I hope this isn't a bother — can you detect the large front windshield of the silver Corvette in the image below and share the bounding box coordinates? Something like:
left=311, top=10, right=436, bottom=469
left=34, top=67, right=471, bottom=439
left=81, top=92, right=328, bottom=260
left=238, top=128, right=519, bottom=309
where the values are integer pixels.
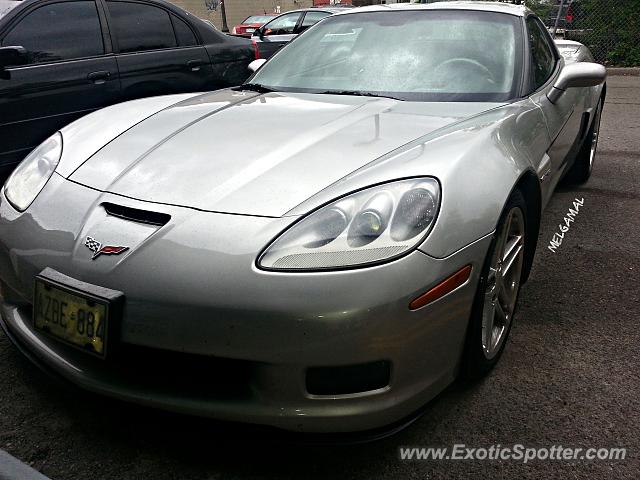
left=250, top=10, right=522, bottom=102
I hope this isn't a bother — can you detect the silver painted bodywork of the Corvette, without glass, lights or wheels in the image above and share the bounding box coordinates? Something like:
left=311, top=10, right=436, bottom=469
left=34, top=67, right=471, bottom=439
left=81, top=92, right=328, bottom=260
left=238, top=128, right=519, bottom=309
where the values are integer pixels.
left=0, top=2, right=602, bottom=431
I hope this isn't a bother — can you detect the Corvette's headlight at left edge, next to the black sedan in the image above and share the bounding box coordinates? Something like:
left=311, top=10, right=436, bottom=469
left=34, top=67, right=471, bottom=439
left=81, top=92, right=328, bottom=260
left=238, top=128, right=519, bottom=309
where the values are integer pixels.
left=4, top=132, right=62, bottom=212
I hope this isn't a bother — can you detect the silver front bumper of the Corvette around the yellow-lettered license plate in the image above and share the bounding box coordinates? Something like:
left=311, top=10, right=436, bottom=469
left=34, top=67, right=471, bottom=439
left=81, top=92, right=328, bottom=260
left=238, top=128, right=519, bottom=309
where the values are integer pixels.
left=0, top=176, right=491, bottom=432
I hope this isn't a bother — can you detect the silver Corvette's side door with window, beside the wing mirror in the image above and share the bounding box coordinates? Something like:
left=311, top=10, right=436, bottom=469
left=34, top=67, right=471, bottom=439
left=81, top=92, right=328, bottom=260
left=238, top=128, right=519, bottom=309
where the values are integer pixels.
left=526, top=16, right=584, bottom=203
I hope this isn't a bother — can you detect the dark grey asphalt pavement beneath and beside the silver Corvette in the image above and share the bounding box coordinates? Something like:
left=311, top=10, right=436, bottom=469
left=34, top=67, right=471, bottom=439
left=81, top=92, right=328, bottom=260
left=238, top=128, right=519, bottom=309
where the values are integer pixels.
left=0, top=76, right=640, bottom=480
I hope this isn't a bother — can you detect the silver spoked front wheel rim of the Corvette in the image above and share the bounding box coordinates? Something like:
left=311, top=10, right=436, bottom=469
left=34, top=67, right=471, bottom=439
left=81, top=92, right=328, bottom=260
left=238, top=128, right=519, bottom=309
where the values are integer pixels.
left=482, top=207, right=525, bottom=360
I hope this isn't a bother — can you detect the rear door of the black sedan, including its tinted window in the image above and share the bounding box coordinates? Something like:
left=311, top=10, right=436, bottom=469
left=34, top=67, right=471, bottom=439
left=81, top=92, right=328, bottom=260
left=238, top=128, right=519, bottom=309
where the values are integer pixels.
left=106, top=0, right=213, bottom=99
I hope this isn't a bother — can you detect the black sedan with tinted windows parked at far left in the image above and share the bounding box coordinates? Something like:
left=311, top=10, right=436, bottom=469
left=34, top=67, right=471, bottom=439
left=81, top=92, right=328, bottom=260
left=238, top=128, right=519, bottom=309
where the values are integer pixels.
left=0, top=0, right=255, bottom=181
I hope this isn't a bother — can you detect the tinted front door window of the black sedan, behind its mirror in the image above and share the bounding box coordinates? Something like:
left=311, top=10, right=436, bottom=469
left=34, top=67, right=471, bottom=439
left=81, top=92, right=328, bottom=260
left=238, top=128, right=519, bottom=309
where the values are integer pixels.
left=2, top=1, right=104, bottom=64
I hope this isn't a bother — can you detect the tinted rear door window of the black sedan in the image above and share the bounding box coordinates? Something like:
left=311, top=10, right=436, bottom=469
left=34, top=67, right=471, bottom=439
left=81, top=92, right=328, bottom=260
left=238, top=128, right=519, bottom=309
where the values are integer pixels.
left=107, top=2, right=177, bottom=53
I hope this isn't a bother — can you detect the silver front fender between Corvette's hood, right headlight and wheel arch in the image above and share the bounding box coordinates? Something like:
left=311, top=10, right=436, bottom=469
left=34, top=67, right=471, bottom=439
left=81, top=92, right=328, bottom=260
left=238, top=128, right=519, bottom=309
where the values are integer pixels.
left=290, top=100, right=549, bottom=258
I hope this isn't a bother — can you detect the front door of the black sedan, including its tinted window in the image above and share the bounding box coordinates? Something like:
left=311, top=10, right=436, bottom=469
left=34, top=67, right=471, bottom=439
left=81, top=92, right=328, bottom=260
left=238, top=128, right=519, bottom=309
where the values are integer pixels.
left=0, top=0, right=120, bottom=178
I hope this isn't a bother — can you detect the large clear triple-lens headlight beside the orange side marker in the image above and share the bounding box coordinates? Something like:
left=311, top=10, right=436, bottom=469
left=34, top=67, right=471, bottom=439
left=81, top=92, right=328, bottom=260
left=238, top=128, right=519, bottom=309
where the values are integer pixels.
left=258, top=178, right=440, bottom=270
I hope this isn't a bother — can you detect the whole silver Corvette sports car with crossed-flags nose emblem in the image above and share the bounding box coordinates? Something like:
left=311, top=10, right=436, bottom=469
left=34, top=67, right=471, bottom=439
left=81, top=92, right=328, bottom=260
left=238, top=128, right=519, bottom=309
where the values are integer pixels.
left=0, top=2, right=606, bottom=432
